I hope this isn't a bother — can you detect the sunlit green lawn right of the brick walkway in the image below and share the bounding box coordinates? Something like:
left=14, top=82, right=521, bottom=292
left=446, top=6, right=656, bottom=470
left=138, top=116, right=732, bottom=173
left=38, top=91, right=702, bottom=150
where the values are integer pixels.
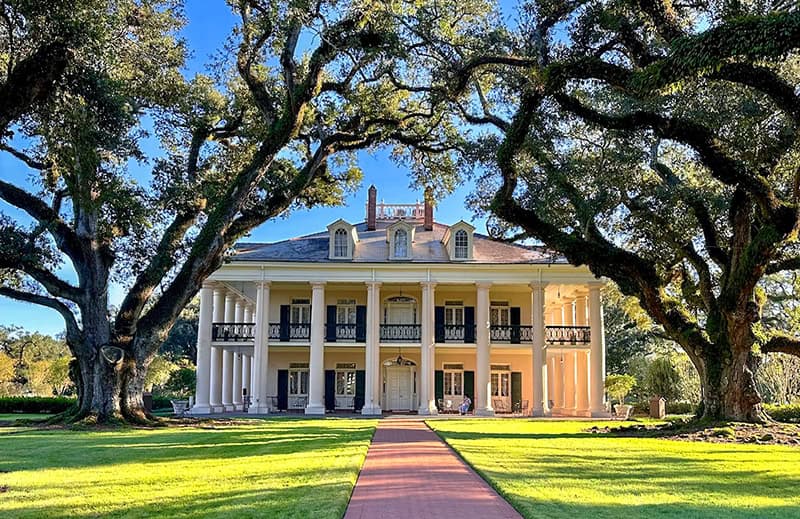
left=428, top=420, right=800, bottom=519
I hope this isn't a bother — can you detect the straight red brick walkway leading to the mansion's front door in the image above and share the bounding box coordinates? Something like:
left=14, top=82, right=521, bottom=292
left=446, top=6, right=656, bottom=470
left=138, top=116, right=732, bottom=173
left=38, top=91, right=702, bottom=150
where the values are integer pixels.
left=345, top=418, right=520, bottom=519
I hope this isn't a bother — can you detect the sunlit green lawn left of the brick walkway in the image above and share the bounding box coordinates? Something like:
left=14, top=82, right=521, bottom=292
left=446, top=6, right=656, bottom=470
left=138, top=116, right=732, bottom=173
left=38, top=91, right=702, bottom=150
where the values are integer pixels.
left=0, top=418, right=375, bottom=518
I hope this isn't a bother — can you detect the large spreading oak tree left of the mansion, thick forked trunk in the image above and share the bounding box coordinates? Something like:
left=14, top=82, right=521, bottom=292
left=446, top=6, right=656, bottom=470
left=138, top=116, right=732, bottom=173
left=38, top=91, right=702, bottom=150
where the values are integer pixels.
left=0, top=0, right=466, bottom=421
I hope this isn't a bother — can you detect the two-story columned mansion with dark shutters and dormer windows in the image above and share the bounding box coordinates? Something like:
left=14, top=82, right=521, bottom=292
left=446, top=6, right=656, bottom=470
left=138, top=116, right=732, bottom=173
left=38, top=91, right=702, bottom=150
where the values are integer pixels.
left=191, top=186, right=605, bottom=416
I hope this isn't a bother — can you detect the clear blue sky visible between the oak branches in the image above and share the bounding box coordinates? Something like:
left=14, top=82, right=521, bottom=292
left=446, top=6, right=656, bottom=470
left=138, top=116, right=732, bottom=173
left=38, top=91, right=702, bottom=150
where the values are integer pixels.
left=0, top=0, right=514, bottom=335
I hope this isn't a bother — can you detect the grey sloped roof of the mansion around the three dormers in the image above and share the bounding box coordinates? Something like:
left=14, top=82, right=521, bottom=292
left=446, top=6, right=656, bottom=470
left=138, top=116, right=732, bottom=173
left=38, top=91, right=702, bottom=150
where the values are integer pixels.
left=231, top=221, right=567, bottom=264
